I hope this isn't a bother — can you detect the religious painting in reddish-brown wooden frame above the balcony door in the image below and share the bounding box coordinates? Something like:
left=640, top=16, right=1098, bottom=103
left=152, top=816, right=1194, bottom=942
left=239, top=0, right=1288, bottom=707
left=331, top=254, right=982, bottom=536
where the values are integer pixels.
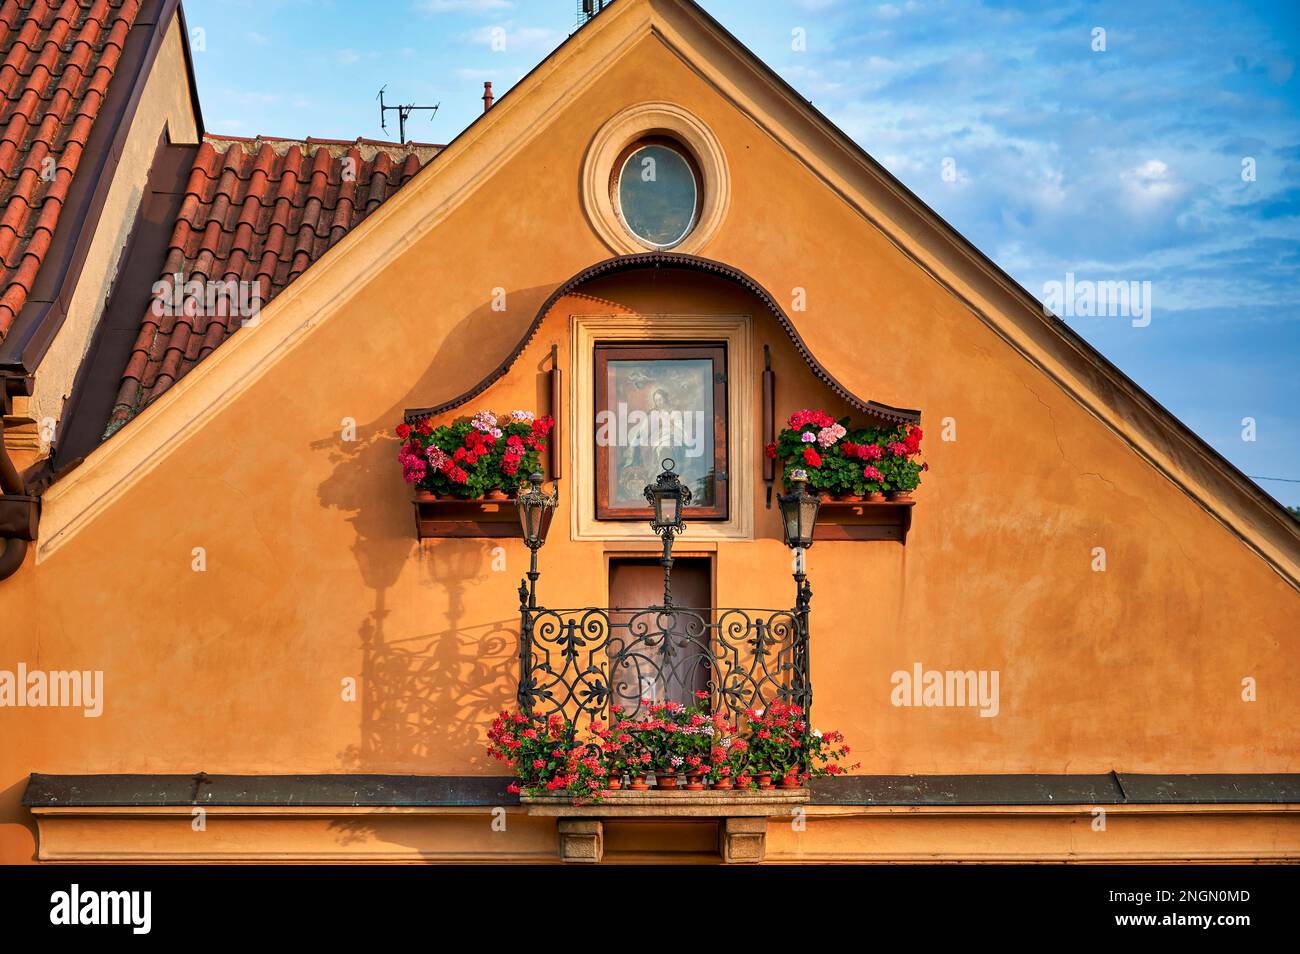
left=594, top=343, right=727, bottom=520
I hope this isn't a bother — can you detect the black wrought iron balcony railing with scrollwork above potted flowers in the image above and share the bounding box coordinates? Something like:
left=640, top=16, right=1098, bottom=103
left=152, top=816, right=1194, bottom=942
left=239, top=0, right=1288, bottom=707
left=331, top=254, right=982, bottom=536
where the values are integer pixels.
left=519, top=573, right=813, bottom=719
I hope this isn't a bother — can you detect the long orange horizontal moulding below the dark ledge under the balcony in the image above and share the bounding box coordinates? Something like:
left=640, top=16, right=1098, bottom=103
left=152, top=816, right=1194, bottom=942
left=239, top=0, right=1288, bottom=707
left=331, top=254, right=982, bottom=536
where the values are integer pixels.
left=31, top=803, right=1300, bottom=863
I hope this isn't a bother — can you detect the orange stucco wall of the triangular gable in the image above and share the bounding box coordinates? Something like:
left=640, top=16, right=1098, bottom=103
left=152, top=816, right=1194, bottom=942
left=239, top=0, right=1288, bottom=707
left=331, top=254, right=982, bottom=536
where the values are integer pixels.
left=0, top=20, right=1300, bottom=862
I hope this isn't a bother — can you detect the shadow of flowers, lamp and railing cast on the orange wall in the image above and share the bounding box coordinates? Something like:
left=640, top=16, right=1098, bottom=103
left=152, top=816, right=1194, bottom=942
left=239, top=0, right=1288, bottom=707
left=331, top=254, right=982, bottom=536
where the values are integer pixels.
left=312, top=295, right=559, bottom=775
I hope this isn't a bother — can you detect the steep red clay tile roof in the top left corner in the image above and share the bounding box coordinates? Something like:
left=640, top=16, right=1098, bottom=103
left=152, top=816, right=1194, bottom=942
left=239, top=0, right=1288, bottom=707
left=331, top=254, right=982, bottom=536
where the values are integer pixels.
left=0, top=0, right=139, bottom=341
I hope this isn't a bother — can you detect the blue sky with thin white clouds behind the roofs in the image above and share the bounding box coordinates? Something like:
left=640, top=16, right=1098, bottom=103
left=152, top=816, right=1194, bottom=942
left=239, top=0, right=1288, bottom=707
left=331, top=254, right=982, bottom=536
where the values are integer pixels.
left=185, top=0, right=1300, bottom=506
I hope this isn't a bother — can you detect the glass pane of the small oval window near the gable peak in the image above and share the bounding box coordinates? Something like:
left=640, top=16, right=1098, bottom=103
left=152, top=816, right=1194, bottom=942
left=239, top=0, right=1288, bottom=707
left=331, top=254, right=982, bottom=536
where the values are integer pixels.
left=619, top=146, right=696, bottom=248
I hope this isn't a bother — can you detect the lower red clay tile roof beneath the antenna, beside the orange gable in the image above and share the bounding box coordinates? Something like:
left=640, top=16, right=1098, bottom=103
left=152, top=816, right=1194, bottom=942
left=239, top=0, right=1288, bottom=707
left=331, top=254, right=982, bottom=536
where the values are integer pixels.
left=105, top=136, right=441, bottom=435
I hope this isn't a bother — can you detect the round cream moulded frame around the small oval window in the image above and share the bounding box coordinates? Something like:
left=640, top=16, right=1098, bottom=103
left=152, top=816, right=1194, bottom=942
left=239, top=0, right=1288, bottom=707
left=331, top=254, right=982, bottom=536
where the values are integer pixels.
left=581, top=103, right=731, bottom=255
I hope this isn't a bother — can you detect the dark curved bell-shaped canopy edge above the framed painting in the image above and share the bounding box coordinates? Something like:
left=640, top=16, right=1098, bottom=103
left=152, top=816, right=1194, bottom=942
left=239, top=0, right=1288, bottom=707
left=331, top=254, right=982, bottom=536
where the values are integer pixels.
left=406, top=252, right=920, bottom=424
